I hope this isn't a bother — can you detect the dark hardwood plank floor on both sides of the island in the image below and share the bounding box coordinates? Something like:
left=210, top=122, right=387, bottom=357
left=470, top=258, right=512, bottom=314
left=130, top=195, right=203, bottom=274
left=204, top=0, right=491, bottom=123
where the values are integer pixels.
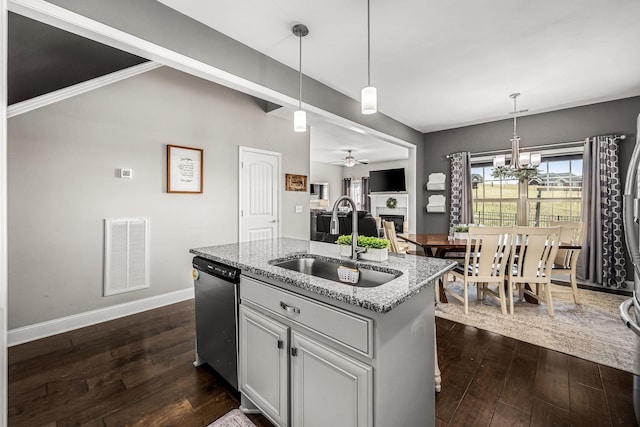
left=9, top=301, right=635, bottom=427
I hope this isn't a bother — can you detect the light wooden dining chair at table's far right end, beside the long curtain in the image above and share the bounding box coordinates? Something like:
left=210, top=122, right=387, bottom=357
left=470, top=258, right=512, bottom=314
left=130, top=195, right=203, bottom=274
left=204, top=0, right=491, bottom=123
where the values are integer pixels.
left=550, top=222, right=583, bottom=304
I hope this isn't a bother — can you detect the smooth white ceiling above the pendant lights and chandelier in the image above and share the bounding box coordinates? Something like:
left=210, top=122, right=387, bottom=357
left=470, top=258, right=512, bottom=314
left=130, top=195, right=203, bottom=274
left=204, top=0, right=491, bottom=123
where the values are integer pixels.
left=160, top=0, right=640, bottom=159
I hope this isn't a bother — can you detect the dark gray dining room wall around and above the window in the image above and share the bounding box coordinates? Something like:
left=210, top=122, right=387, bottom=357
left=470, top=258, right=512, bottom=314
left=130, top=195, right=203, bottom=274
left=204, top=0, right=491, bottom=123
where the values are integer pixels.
left=417, top=97, right=640, bottom=233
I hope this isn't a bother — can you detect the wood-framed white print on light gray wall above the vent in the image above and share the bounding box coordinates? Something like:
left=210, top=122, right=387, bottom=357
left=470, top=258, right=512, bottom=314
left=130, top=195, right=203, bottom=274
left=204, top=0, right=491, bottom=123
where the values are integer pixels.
left=167, top=145, right=204, bottom=193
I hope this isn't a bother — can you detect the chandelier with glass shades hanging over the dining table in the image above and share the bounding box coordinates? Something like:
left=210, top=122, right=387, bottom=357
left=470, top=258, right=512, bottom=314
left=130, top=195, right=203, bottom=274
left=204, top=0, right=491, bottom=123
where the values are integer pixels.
left=492, top=93, right=542, bottom=181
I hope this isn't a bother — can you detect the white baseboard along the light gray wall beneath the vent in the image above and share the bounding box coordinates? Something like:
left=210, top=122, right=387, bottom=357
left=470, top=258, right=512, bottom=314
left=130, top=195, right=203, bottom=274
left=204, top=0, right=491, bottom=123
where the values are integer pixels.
left=7, top=288, right=193, bottom=347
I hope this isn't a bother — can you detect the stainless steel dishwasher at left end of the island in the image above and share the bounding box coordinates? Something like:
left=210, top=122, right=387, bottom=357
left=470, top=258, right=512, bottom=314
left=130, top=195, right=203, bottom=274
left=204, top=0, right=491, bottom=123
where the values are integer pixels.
left=193, top=257, right=240, bottom=390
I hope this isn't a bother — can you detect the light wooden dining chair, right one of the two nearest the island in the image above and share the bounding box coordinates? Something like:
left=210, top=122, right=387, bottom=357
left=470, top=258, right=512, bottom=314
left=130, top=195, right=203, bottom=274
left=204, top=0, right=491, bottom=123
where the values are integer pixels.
left=507, top=227, right=560, bottom=317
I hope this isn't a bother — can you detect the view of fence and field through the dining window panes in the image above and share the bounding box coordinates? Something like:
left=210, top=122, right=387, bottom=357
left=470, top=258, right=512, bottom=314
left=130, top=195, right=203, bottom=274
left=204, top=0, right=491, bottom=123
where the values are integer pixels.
left=471, top=157, right=582, bottom=227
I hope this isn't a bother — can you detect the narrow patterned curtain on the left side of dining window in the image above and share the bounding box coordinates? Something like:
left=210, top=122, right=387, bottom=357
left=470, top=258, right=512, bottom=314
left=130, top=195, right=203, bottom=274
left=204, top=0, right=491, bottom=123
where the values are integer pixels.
left=449, top=151, right=473, bottom=227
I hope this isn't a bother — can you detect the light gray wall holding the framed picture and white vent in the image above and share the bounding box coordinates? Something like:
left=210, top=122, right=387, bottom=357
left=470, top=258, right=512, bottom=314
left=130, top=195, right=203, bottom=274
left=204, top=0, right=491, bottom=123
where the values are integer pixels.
left=8, top=68, right=310, bottom=328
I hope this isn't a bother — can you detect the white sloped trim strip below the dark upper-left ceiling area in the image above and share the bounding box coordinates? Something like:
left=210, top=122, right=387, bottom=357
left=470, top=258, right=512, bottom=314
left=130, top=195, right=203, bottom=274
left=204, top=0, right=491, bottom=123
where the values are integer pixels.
left=7, top=61, right=162, bottom=118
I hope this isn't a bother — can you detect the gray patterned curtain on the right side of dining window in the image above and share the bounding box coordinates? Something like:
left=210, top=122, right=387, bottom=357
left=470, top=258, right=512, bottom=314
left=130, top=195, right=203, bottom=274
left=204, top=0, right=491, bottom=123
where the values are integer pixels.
left=577, top=136, right=626, bottom=288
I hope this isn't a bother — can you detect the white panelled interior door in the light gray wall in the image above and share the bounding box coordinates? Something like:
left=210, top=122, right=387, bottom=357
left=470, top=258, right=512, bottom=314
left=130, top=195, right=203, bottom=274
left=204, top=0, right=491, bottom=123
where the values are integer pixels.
left=238, top=147, right=281, bottom=242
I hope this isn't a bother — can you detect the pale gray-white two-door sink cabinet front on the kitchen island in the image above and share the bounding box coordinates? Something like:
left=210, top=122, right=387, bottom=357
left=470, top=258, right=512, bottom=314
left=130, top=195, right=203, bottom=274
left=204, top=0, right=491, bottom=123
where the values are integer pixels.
left=239, top=280, right=373, bottom=427
